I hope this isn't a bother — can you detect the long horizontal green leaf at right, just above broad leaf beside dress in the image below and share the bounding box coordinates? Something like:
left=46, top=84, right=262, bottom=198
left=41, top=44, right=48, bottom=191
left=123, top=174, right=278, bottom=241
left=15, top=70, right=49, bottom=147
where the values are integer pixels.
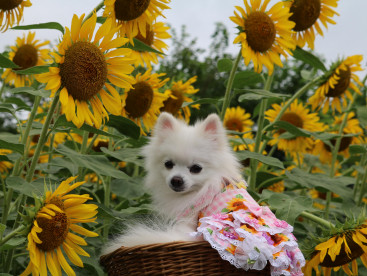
left=285, top=168, right=355, bottom=200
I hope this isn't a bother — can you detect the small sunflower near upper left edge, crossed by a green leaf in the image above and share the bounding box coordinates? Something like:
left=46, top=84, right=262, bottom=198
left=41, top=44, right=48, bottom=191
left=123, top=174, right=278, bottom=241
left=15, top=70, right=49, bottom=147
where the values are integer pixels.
left=1, top=32, right=50, bottom=87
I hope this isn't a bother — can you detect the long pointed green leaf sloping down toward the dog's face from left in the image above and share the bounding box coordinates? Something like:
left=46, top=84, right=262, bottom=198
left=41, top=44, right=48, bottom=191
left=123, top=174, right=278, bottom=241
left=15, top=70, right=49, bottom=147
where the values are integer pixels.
left=56, top=145, right=129, bottom=179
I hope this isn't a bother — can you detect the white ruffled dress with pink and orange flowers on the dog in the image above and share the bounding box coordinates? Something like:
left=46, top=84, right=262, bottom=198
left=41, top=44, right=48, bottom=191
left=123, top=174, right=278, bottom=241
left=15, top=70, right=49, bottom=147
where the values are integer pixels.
left=193, top=181, right=305, bottom=276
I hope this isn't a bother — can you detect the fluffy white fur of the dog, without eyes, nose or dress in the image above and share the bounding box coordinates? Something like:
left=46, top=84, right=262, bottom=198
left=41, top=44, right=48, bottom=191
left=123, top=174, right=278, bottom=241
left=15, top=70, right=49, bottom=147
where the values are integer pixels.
left=103, top=112, right=240, bottom=254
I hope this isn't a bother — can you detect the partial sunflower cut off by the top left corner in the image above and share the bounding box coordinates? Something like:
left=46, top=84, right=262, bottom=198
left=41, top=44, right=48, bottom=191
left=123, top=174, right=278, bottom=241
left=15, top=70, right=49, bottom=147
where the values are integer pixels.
left=0, top=0, right=32, bottom=32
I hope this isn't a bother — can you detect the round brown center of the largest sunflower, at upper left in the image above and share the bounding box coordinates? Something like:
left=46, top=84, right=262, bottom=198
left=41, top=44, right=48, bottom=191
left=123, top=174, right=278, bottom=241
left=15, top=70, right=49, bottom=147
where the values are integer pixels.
left=60, top=41, right=107, bottom=101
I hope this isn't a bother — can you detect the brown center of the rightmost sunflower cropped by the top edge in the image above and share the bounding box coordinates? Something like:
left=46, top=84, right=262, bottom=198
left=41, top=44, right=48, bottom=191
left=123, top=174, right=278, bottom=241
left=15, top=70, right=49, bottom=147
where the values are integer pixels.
left=289, top=0, right=321, bottom=32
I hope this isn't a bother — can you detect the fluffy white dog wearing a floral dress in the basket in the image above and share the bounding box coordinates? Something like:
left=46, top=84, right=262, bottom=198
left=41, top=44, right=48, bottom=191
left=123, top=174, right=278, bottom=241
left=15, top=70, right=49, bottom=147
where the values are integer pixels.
left=103, top=113, right=305, bottom=275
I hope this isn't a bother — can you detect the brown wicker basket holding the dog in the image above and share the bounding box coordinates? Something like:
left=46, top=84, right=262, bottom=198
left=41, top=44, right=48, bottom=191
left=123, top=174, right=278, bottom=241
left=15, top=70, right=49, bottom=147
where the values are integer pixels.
left=100, top=241, right=270, bottom=276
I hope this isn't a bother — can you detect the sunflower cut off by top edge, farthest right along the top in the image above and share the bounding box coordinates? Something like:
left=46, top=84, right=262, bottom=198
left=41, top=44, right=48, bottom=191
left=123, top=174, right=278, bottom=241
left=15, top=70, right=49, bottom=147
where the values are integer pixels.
left=284, top=0, right=339, bottom=49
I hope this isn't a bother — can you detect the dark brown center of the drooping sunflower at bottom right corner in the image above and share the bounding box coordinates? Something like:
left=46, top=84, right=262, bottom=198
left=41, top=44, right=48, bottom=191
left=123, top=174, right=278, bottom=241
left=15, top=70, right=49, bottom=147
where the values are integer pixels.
left=320, top=230, right=364, bottom=267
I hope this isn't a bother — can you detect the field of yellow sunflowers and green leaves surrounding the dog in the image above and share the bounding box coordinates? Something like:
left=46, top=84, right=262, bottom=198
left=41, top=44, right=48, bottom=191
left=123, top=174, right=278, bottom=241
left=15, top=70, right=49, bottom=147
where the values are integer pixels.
left=0, top=0, right=367, bottom=276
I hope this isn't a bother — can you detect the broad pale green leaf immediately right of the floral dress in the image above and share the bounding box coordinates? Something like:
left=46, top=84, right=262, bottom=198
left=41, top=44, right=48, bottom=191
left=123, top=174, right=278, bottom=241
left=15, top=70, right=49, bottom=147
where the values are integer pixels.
left=268, top=193, right=313, bottom=225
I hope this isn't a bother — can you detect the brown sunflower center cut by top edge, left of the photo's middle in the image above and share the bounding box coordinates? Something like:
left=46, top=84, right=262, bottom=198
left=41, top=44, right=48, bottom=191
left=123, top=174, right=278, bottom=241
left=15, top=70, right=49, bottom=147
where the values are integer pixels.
left=115, top=0, right=150, bottom=21
